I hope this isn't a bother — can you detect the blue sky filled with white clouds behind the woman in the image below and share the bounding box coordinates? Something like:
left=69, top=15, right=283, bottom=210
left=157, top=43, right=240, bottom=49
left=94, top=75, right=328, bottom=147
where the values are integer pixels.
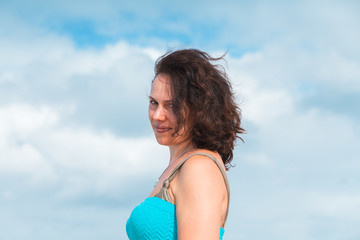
left=0, top=0, right=360, bottom=240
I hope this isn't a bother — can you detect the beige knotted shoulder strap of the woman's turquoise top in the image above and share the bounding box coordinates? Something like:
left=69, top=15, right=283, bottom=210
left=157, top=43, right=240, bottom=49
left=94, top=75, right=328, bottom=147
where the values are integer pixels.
left=155, top=152, right=230, bottom=228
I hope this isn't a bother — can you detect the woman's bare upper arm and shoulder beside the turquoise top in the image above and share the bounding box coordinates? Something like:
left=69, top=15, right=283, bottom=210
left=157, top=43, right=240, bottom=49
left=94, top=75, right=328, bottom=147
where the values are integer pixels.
left=174, top=155, right=226, bottom=240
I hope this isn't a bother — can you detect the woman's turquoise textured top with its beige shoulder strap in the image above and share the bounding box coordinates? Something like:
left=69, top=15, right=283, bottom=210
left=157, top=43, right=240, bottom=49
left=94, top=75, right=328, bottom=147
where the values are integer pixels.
left=126, top=153, right=230, bottom=240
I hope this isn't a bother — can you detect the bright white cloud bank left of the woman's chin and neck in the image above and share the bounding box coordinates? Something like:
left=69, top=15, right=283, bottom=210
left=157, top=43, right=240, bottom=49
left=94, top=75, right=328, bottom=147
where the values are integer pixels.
left=0, top=104, right=167, bottom=197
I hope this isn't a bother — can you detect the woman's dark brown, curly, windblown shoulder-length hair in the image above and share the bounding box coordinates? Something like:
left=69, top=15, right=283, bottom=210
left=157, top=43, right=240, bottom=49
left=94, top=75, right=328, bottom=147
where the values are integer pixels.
left=155, top=49, right=245, bottom=170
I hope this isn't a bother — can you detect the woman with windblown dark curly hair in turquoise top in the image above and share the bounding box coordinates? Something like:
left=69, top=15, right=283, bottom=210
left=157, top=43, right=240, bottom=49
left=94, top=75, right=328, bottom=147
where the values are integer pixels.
left=126, top=49, right=244, bottom=240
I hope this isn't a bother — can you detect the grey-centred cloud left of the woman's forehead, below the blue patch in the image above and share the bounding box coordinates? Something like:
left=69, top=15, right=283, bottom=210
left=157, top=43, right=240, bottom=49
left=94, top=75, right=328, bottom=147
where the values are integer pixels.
left=0, top=16, right=160, bottom=136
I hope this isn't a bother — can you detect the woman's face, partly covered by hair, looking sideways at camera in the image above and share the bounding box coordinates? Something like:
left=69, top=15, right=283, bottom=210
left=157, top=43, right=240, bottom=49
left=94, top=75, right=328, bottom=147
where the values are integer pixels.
left=149, top=74, right=187, bottom=146
